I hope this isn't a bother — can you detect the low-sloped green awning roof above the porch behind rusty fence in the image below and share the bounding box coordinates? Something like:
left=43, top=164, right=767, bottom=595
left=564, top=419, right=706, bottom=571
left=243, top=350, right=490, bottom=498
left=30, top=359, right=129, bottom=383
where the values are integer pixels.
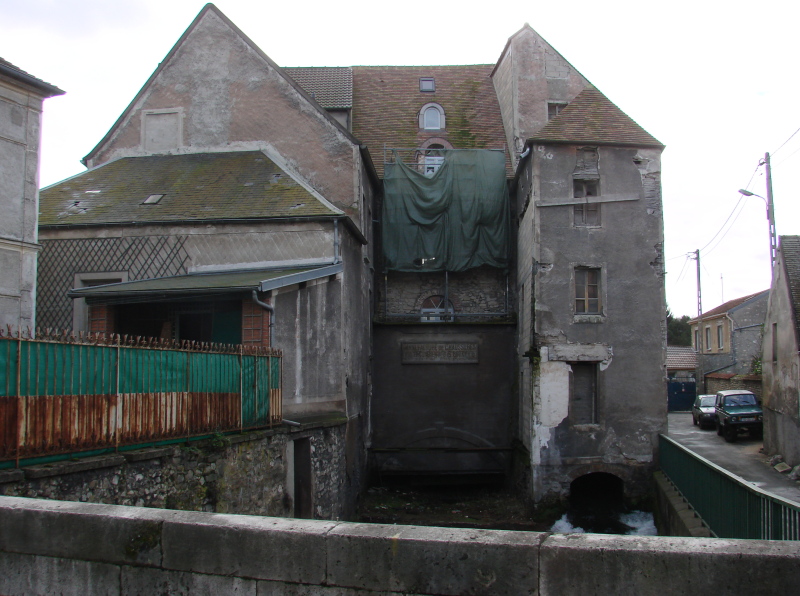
left=68, top=263, right=343, bottom=303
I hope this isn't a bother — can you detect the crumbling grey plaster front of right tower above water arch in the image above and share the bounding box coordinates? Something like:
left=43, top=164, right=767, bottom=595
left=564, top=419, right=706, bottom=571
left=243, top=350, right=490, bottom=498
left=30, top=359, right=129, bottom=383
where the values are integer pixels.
left=517, top=145, right=666, bottom=500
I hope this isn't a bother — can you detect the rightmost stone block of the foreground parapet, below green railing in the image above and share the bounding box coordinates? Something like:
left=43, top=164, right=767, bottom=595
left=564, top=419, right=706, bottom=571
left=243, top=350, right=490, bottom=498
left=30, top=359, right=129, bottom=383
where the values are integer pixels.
left=539, top=534, right=800, bottom=595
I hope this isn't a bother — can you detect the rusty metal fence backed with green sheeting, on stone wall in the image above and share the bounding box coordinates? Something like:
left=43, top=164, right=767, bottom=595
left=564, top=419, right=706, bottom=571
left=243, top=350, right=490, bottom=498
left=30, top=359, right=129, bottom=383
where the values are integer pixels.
left=0, top=334, right=282, bottom=463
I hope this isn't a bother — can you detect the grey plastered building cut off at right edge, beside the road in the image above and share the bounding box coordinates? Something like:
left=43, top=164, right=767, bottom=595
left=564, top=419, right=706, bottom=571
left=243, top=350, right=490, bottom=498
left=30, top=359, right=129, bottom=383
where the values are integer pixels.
left=762, top=236, right=800, bottom=466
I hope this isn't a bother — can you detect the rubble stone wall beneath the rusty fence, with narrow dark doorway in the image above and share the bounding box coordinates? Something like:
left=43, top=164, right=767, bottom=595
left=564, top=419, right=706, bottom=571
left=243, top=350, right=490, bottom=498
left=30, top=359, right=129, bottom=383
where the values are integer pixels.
left=0, top=422, right=347, bottom=519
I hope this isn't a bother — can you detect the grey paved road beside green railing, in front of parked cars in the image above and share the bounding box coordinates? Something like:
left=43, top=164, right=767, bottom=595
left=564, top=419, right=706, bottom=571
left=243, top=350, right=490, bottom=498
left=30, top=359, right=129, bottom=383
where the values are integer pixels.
left=667, top=412, right=800, bottom=503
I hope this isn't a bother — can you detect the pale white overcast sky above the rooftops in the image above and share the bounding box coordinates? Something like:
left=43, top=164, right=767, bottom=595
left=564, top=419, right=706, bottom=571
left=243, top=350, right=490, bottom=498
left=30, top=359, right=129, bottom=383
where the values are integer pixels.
left=0, top=0, right=800, bottom=316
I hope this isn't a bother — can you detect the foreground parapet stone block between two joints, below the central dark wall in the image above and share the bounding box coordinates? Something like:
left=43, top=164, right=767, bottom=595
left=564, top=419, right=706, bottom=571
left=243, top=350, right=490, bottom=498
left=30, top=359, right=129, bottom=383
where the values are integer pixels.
left=328, top=523, right=547, bottom=595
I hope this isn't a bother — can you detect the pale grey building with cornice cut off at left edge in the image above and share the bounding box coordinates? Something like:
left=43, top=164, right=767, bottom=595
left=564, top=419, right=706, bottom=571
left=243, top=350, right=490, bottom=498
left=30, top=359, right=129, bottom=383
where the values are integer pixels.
left=0, top=58, right=64, bottom=333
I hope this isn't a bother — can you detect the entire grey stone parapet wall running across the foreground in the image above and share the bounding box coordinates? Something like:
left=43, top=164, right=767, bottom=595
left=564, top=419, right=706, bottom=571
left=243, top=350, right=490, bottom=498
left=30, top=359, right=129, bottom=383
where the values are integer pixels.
left=0, top=497, right=800, bottom=596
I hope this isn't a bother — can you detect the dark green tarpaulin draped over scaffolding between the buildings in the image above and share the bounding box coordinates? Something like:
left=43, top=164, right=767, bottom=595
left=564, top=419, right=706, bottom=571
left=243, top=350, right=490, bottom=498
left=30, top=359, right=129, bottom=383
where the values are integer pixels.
left=382, top=149, right=509, bottom=271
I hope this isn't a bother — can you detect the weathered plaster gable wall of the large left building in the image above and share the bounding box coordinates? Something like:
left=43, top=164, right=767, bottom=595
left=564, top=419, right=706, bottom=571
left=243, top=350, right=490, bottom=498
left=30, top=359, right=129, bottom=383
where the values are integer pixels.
left=87, top=10, right=362, bottom=225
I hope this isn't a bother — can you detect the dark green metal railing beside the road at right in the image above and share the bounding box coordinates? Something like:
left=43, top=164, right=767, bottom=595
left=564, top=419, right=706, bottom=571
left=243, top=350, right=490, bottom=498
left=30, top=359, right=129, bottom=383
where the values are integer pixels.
left=659, top=435, right=800, bottom=540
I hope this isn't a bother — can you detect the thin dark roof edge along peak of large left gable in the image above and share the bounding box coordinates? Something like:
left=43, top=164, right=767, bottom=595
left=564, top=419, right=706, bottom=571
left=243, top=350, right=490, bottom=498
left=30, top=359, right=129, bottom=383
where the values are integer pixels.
left=81, top=3, right=359, bottom=165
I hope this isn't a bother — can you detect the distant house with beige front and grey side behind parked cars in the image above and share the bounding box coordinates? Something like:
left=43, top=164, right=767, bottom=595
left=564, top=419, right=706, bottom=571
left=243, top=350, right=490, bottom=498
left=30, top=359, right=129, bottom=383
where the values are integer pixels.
left=689, top=290, right=769, bottom=396
